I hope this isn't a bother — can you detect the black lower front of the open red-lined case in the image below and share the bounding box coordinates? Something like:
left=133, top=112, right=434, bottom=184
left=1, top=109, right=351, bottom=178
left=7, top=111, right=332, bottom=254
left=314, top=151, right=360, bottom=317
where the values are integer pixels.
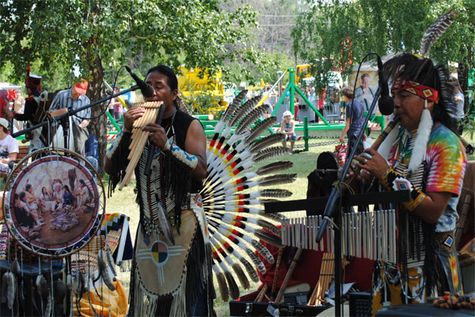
left=229, top=301, right=329, bottom=317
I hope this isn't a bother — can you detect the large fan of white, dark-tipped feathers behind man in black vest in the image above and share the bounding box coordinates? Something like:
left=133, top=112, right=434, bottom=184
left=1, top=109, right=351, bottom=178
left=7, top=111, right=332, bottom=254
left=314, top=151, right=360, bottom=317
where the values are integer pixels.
left=201, top=92, right=296, bottom=300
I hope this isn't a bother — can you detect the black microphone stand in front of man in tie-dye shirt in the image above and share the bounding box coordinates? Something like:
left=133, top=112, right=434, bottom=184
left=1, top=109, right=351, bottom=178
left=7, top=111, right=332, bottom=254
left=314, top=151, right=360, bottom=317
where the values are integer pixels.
left=315, top=86, right=381, bottom=317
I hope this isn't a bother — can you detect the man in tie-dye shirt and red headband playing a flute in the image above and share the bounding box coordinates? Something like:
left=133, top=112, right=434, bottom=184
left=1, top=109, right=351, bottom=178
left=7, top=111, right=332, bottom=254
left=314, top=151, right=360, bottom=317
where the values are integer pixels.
left=356, top=54, right=466, bottom=295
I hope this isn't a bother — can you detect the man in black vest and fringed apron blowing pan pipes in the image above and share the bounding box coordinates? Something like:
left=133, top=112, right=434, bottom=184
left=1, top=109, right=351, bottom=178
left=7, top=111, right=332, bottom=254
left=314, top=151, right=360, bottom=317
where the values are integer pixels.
left=106, top=65, right=212, bottom=316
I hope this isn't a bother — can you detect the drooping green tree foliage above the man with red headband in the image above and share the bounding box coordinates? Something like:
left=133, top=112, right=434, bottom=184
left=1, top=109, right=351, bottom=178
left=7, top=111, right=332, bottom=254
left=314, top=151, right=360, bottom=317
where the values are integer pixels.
left=292, top=0, right=475, bottom=91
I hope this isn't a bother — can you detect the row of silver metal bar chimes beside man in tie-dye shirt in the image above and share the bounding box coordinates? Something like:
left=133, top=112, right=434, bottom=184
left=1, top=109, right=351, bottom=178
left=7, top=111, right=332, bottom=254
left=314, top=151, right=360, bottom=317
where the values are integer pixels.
left=281, top=209, right=397, bottom=263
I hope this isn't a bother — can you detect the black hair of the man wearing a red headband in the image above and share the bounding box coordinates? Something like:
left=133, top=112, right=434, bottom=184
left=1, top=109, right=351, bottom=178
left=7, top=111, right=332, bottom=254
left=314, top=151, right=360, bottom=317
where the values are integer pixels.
left=384, top=53, right=457, bottom=132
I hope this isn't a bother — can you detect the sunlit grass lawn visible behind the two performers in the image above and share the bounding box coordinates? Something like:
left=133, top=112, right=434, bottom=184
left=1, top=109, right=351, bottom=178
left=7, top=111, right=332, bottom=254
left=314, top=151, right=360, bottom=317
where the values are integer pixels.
left=106, top=130, right=475, bottom=316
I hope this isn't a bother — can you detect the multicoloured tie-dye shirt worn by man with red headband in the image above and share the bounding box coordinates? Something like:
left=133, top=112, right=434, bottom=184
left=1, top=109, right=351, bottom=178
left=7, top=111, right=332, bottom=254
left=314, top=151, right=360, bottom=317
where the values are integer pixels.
left=392, top=124, right=467, bottom=232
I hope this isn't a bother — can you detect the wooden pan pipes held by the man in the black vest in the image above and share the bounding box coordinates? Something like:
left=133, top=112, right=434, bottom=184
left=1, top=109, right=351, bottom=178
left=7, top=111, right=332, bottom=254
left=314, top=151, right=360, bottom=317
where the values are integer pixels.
left=119, top=101, right=162, bottom=189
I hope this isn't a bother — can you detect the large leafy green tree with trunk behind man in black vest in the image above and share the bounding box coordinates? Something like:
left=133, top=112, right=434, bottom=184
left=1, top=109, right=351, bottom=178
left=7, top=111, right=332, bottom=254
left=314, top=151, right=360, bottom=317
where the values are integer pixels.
left=0, top=0, right=255, bottom=168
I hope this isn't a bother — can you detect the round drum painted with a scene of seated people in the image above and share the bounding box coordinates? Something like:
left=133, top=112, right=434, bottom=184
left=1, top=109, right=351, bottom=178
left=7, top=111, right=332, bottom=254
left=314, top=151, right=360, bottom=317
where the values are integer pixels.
left=3, top=149, right=105, bottom=257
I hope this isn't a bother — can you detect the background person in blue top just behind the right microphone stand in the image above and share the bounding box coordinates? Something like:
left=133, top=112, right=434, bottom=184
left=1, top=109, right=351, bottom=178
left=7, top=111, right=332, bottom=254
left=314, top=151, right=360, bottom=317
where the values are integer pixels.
left=340, top=87, right=364, bottom=154
